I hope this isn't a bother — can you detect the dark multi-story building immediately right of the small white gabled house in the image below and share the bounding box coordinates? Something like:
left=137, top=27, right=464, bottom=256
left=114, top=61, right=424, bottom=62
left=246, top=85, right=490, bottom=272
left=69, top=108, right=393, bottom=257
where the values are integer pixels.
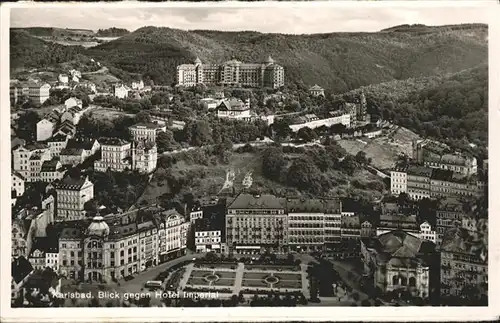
left=436, top=198, right=467, bottom=246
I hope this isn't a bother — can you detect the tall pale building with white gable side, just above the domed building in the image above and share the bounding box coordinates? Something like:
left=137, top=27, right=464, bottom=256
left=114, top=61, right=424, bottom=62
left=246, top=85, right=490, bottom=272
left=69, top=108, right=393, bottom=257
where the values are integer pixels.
left=54, top=177, right=94, bottom=221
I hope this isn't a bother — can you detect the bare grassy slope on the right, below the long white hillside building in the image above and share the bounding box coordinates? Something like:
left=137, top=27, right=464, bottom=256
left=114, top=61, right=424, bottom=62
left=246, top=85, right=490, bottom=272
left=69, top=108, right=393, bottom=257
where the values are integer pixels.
left=339, top=128, right=419, bottom=169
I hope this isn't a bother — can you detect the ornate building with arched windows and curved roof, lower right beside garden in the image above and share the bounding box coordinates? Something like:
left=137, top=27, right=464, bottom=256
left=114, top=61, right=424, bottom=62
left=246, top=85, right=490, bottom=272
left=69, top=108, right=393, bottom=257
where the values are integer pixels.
left=361, top=230, right=434, bottom=299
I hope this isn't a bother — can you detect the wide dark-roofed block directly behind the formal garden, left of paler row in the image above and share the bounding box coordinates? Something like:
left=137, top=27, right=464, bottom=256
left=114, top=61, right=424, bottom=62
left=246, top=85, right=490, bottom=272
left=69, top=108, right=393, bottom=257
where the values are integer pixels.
left=226, top=194, right=288, bottom=253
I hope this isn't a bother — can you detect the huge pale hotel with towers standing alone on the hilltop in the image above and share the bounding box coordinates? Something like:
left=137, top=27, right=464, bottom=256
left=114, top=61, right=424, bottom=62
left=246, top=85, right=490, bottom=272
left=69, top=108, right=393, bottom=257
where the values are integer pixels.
left=177, top=57, right=285, bottom=89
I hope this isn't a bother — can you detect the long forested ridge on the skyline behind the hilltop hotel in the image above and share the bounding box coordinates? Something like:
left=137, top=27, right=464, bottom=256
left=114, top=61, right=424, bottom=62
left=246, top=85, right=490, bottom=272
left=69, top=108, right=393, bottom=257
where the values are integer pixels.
left=87, top=25, right=488, bottom=93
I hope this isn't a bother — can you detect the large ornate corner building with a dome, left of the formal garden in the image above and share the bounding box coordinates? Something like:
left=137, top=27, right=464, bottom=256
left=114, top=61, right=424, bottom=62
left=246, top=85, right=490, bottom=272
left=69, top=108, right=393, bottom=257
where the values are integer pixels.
left=59, top=209, right=187, bottom=281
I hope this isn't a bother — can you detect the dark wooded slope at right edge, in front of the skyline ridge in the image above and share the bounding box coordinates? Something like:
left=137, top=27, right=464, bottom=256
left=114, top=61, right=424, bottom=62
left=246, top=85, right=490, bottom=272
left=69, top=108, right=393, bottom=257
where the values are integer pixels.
left=342, top=64, right=488, bottom=158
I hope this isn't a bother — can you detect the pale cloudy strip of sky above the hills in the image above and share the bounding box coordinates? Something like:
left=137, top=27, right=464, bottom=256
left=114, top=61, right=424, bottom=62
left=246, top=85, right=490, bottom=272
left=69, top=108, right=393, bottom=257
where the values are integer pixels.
left=10, top=3, right=487, bottom=34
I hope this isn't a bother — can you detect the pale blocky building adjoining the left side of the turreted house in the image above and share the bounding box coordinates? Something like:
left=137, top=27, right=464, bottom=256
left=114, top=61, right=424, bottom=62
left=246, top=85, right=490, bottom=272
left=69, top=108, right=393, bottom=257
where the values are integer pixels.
left=94, top=138, right=132, bottom=172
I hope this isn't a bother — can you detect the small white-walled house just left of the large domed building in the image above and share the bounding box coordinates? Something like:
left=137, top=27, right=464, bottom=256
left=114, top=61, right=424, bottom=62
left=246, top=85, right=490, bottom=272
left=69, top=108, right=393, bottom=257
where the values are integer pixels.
left=28, top=237, right=59, bottom=272
